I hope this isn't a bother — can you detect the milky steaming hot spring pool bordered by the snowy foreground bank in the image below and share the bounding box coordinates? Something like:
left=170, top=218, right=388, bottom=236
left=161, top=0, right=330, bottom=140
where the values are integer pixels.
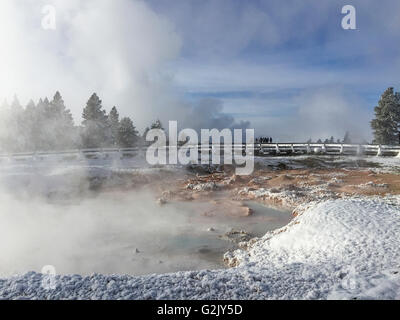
left=0, top=186, right=291, bottom=276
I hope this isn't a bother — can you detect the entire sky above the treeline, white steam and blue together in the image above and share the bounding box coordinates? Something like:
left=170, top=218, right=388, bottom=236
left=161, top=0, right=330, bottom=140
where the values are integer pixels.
left=0, top=0, right=400, bottom=141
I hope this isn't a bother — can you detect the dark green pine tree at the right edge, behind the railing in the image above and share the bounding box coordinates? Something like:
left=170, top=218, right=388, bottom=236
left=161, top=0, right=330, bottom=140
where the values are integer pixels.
left=371, top=88, right=400, bottom=144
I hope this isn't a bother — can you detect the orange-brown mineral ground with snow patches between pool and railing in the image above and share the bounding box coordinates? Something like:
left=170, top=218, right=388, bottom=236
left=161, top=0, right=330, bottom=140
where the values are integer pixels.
left=140, top=159, right=400, bottom=216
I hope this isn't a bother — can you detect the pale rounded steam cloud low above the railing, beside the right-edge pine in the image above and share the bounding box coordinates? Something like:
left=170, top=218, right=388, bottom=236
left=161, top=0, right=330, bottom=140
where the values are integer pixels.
left=242, top=87, right=372, bottom=142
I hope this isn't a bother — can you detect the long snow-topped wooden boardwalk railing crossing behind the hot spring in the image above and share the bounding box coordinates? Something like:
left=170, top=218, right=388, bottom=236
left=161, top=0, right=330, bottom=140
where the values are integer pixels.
left=0, top=143, right=400, bottom=160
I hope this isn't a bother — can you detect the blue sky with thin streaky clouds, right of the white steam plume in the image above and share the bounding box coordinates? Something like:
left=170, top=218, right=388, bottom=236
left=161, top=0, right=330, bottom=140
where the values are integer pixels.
left=151, top=0, right=400, bottom=139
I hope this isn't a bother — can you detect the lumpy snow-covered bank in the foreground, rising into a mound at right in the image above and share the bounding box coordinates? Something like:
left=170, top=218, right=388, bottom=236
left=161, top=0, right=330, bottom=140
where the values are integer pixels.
left=0, top=197, right=400, bottom=299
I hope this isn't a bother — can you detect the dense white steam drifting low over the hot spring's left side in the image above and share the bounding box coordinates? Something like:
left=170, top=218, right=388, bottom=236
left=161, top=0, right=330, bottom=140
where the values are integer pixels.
left=0, top=163, right=220, bottom=277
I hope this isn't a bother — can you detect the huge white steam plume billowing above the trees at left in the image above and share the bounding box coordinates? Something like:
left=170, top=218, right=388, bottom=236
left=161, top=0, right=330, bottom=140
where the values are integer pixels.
left=0, top=0, right=248, bottom=129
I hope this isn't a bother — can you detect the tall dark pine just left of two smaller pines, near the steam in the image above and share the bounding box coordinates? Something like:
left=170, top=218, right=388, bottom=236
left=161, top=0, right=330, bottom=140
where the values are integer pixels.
left=82, top=93, right=109, bottom=148
